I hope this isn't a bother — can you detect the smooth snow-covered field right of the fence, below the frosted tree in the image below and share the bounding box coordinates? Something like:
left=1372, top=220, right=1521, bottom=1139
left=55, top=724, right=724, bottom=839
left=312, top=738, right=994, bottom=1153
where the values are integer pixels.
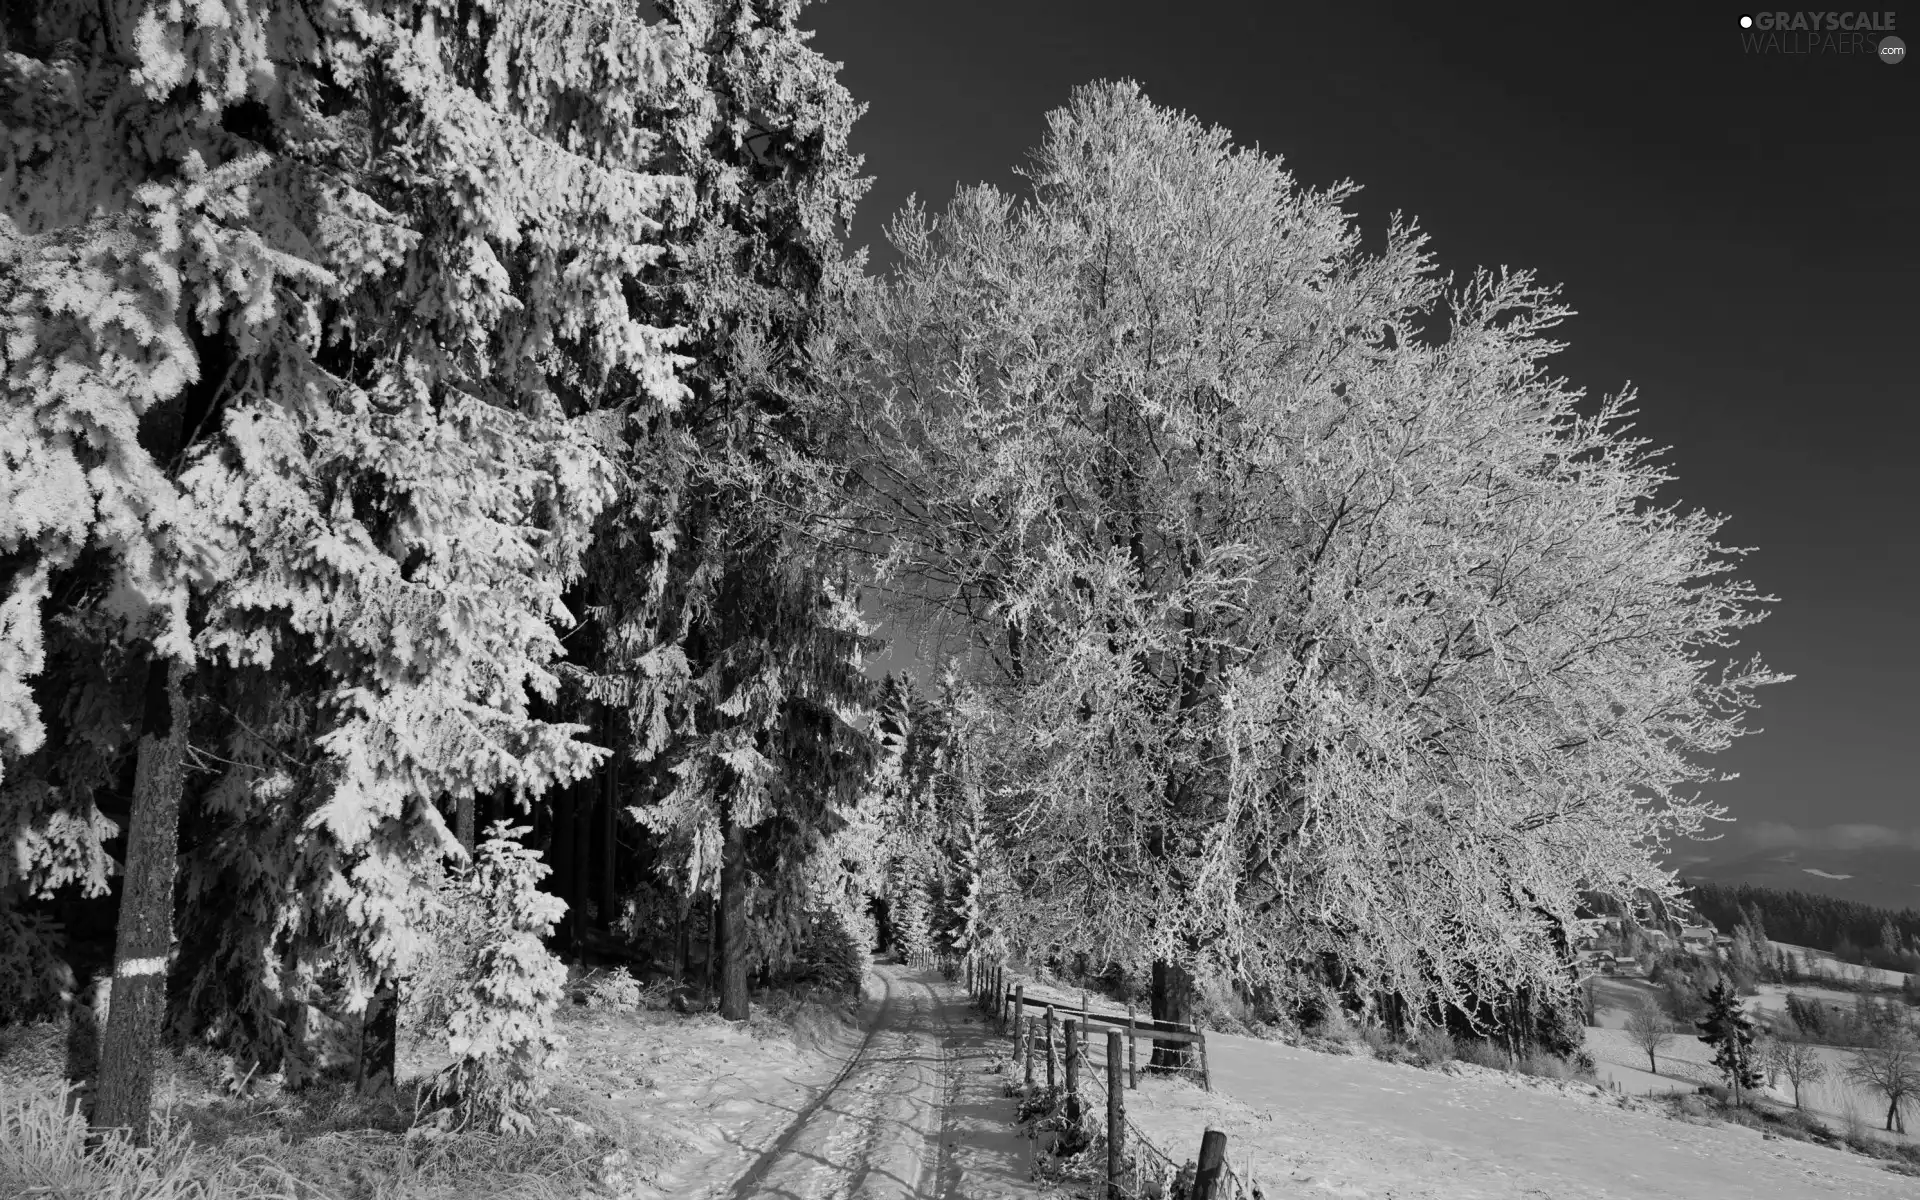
left=1129, top=1035, right=1920, bottom=1200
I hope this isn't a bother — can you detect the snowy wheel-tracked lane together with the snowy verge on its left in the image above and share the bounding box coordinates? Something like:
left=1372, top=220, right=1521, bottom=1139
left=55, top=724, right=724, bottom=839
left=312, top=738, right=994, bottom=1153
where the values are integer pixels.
left=595, top=964, right=1041, bottom=1200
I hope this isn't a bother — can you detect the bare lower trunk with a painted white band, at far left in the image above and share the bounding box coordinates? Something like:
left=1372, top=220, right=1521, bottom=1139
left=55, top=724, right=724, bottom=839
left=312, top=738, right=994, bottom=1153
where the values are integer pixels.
left=92, top=660, right=186, bottom=1146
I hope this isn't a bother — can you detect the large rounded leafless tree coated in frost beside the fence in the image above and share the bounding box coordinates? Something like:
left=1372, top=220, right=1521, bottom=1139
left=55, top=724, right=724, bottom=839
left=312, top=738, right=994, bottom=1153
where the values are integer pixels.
left=862, top=84, right=1776, bottom=1052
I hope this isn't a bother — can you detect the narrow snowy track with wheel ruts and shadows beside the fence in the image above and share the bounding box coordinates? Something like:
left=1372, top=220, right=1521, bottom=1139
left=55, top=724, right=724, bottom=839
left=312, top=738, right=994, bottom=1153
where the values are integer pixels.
left=699, top=964, right=1041, bottom=1200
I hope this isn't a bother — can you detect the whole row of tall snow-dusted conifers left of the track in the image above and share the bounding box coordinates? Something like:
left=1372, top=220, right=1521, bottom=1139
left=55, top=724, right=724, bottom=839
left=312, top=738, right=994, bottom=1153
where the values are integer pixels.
left=0, top=0, right=870, bottom=1127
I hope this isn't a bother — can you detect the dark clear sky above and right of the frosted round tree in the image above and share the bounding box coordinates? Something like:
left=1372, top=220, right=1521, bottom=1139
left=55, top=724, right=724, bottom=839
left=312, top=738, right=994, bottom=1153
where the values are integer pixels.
left=810, top=0, right=1920, bottom=849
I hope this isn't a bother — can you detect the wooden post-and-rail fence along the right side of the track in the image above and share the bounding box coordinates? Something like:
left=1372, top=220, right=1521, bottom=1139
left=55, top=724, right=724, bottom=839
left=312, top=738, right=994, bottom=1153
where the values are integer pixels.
left=948, top=954, right=1261, bottom=1200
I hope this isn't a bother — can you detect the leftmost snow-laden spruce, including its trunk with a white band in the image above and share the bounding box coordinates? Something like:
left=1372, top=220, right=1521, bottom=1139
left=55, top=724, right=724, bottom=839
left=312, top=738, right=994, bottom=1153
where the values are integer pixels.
left=0, top=4, right=332, bottom=1140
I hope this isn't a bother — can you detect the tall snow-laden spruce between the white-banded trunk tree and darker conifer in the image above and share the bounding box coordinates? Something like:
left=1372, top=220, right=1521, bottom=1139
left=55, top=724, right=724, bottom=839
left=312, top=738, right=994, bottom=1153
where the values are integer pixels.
left=174, top=4, right=687, bottom=1079
